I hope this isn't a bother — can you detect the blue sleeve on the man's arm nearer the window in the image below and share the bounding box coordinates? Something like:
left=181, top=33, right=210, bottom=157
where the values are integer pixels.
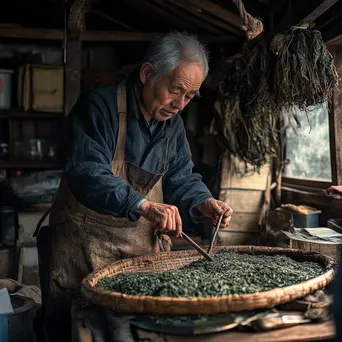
left=163, top=124, right=213, bottom=222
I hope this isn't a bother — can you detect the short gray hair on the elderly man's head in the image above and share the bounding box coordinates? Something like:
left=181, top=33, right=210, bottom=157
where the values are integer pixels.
left=143, top=32, right=209, bottom=82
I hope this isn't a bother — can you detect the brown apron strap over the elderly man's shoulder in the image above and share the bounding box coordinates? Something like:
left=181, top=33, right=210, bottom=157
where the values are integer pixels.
left=112, top=82, right=127, bottom=175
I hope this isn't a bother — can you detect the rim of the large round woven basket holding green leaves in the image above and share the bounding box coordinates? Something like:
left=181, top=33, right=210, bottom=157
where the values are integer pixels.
left=82, top=245, right=336, bottom=314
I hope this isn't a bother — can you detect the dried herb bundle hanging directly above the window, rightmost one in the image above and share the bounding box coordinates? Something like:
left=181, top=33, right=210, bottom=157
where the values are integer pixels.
left=270, top=26, right=338, bottom=110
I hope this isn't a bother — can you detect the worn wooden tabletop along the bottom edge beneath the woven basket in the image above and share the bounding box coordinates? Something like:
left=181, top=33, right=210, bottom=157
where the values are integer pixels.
left=136, top=321, right=335, bottom=342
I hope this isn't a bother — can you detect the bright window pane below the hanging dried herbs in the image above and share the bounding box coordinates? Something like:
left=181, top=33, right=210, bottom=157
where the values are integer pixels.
left=283, top=103, right=332, bottom=182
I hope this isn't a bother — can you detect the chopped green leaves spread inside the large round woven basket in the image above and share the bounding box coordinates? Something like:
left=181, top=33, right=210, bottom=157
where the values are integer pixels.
left=97, top=250, right=324, bottom=297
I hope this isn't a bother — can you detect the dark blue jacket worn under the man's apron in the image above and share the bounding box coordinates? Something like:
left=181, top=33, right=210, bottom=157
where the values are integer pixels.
left=63, top=75, right=212, bottom=221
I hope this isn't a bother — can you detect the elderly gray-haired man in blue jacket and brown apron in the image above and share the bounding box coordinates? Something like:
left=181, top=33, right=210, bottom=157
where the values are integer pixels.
left=37, top=33, right=232, bottom=342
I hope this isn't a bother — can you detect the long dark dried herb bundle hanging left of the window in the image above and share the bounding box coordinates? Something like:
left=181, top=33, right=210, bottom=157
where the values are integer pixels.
left=215, top=36, right=280, bottom=169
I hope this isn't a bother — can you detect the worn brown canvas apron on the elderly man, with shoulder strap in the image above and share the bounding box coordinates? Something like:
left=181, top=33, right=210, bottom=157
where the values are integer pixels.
left=37, top=84, right=171, bottom=342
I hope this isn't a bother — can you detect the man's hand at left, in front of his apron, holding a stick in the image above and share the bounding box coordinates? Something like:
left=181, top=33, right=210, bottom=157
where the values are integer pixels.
left=138, top=201, right=182, bottom=237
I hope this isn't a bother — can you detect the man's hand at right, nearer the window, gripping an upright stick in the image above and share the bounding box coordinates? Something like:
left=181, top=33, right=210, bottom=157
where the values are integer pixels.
left=197, top=198, right=233, bottom=228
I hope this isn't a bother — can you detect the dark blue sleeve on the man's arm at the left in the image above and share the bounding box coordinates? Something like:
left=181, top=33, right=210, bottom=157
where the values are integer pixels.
left=64, top=92, right=143, bottom=221
